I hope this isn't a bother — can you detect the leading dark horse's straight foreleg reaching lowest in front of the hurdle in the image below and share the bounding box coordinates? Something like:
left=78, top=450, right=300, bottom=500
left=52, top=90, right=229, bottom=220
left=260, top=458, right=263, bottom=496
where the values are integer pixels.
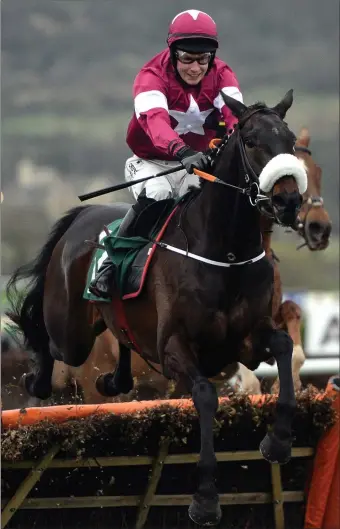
left=164, top=336, right=221, bottom=526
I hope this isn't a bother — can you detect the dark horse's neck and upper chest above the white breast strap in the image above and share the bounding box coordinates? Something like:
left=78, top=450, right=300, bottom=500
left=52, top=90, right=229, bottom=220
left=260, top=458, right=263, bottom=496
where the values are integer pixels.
left=189, top=140, right=261, bottom=261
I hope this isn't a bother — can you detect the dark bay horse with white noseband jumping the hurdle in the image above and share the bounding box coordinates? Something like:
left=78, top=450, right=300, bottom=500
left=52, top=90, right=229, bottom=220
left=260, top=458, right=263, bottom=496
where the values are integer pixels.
left=8, top=91, right=307, bottom=525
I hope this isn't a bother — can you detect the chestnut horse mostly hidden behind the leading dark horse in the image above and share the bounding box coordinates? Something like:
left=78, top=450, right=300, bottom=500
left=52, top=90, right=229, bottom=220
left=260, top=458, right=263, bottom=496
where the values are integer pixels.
left=49, top=127, right=332, bottom=404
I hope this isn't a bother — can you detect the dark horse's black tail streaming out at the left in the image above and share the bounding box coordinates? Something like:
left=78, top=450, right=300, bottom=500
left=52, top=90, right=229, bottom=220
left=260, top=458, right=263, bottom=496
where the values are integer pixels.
left=6, top=206, right=89, bottom=352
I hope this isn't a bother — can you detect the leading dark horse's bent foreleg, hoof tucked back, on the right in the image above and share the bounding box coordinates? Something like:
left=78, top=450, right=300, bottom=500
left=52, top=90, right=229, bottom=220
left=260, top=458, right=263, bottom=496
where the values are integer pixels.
left=260, top=330, right=296, bottom=464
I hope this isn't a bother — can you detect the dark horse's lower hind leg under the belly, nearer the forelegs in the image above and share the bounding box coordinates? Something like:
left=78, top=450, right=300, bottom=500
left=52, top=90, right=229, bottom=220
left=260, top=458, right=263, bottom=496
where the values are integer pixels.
left=96, top=343, right=133, bottom=397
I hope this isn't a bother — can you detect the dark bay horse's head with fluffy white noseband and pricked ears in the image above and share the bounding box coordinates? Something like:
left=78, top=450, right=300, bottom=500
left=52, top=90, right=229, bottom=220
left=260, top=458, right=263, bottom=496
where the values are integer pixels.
left=222, top=90, right=307, bottom=227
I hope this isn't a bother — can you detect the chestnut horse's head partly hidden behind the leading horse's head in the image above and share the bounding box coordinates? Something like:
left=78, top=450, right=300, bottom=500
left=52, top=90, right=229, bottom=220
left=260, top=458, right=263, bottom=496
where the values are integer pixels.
left=295, top=127, right=332, bottom=250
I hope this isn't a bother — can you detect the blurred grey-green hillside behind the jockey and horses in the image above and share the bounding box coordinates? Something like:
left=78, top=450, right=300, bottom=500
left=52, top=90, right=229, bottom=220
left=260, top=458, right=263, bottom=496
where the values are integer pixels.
left=1, top=0, right=339, bottom=289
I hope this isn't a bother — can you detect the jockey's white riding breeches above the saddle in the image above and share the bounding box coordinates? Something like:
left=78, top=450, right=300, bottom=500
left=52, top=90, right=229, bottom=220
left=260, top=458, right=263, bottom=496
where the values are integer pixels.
left=125, top=156, right=199, bottom=200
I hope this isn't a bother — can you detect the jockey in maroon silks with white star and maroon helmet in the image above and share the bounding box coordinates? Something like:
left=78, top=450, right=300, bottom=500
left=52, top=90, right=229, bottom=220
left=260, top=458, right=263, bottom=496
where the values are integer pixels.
left=90, top=9, right=243, bottom=298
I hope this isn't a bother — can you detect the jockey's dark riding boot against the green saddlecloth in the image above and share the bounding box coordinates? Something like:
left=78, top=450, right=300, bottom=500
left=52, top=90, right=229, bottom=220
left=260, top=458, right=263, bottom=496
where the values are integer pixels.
left=89, top=197, right=154, bottom=299
